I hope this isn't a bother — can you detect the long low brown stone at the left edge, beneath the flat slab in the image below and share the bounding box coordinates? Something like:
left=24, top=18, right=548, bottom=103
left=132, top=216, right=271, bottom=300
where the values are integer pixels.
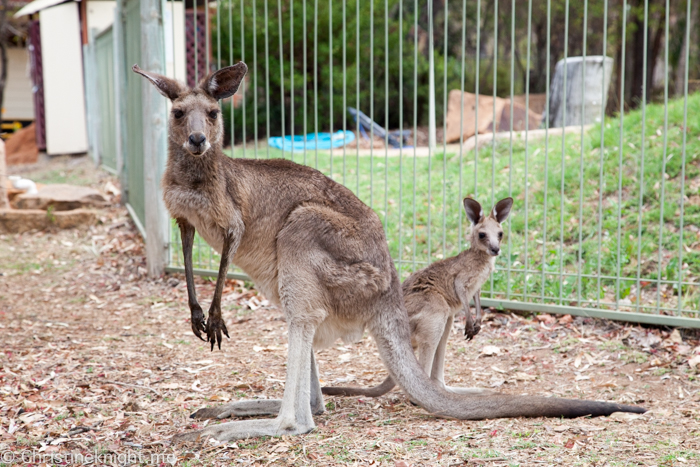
left=0, top=209, right=97, bottom=234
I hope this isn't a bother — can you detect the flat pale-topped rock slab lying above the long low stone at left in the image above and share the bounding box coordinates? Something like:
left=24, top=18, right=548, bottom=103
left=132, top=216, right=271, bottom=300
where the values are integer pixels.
left=13, top=184, right=107, bottom=211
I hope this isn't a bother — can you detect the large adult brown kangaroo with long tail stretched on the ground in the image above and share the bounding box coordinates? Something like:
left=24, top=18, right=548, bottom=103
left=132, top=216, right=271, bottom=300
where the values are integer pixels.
left=133, top=62, right=645, bottom=441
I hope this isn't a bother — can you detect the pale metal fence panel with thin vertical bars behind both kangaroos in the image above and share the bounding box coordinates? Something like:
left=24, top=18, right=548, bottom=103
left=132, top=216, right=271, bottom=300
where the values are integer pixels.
left=169, top=0, right=700, bottom=327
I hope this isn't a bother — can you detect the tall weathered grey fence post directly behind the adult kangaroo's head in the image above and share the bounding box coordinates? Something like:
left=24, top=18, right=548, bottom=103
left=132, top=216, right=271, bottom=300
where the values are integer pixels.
left=139, top=0, right=168, bottom=277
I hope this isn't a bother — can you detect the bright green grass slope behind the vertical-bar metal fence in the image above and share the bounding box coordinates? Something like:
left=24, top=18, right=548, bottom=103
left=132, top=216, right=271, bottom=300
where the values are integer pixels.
left=173, top=94, right=700, bottom=316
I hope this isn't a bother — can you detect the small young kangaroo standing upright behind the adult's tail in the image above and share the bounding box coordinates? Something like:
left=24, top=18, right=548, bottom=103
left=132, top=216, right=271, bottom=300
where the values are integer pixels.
left=321, top=198, right=513, bottom=397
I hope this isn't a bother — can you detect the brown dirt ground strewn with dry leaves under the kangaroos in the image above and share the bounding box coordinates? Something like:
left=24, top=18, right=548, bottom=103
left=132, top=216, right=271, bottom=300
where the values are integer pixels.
left=0, top=159, right=700, bottom=467
